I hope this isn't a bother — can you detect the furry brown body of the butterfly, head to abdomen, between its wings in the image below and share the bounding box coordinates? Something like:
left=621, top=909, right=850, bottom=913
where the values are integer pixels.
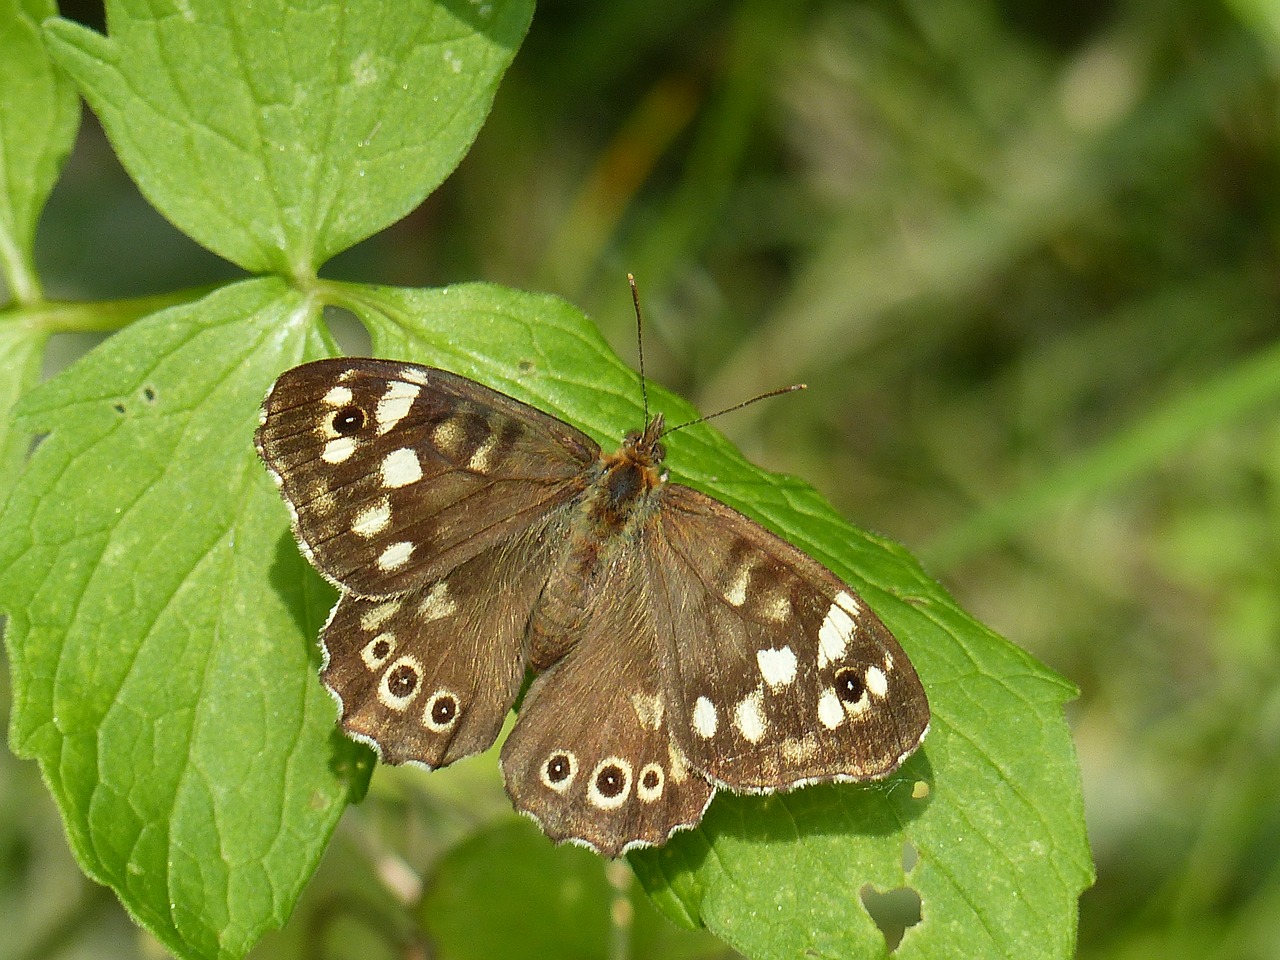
left=529, top=413, right=666, bottom=669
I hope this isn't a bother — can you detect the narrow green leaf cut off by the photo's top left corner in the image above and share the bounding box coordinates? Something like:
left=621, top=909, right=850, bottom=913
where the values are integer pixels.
left=0, top=0, right=79, bottom=304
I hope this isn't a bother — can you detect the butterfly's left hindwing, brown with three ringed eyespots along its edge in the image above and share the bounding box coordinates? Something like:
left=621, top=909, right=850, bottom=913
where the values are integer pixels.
left=320, top=515, right=559, bottom=767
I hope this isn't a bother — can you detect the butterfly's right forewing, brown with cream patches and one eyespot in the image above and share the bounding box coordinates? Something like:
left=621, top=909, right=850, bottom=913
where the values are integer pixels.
left=648, top=484, right=929, bottom=792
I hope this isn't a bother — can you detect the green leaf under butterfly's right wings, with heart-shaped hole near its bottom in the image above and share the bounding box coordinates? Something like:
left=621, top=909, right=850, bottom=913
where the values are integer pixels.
left=325, top=284, right=1093, bottom=957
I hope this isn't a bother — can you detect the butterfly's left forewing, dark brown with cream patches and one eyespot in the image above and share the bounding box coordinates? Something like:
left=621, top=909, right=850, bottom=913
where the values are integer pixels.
left=256, top=358, right=599, bottom=596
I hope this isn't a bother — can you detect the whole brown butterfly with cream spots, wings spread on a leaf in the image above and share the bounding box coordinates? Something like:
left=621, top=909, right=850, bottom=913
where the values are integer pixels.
left=255, top=357, right=929, bottom=858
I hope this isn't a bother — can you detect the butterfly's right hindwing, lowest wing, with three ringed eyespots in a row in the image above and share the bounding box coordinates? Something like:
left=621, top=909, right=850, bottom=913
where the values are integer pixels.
left=502, top=550, right=716, bottom=856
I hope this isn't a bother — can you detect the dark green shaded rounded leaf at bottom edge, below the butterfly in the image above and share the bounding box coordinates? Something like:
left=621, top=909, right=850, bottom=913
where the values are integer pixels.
left=419, top=820, right=724, bottom=960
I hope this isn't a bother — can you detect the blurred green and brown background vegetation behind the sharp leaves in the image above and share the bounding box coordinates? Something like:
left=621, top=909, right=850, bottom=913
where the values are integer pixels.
left=0, top=0, right=1280, bottom=960
